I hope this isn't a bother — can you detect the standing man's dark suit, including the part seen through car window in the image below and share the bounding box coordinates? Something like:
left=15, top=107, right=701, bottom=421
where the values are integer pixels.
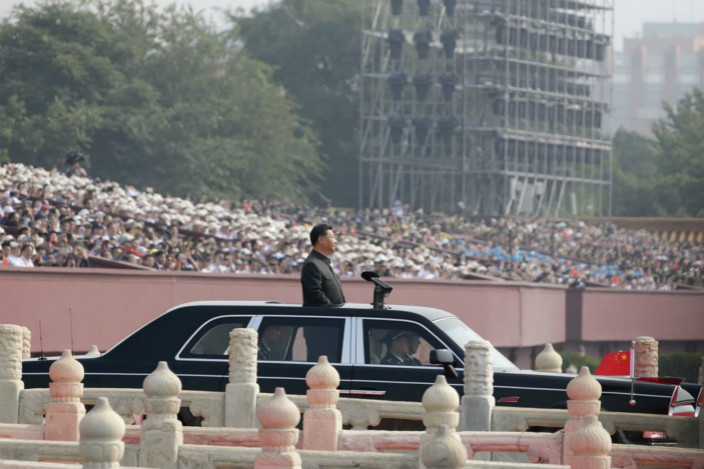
left=301, top=249, right=345, bottom=363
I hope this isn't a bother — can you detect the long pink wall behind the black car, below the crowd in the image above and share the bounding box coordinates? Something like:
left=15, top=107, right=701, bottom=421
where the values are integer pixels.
left=0, top=268, right=704, bottom=352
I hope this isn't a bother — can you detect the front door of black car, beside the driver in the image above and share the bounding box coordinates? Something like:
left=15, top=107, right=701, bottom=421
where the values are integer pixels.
left=348, top=318, right=462, bottom=401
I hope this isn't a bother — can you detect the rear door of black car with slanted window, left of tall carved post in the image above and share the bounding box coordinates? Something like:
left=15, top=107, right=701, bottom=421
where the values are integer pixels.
left=169, top=315, right=252, bottom=391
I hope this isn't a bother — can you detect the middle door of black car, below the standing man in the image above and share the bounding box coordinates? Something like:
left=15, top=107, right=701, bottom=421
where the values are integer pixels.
left=256, top=315, right=352, bottom=395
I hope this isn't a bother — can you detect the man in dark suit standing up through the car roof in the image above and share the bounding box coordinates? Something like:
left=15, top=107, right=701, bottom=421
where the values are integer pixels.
left=301, top=223, right=345, bottom=306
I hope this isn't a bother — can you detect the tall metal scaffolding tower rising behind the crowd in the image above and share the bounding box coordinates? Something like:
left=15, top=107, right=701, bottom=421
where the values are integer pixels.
left=360, top=0, right=614, bottom=217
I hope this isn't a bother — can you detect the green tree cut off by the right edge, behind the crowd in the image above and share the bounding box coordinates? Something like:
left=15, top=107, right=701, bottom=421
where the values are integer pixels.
left=653, top=88, right=704, bottom=217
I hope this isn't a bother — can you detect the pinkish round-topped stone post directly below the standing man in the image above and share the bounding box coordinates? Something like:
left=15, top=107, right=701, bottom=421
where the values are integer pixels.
left=303, top=355, right=342, bottom=451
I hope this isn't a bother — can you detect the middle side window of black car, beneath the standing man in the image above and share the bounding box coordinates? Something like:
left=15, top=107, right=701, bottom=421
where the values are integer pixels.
left=258, top=317, right=345, bottom=363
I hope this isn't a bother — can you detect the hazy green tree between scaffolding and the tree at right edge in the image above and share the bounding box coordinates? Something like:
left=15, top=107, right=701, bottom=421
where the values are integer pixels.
left=612, top=128, right=658, bottom=217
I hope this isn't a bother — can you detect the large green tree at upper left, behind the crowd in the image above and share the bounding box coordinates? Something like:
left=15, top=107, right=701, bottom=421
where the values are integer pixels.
left=0, top=0, right=320, bottom=201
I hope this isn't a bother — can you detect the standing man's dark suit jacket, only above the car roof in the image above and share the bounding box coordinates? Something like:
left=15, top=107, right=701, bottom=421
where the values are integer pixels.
left=301, top=249, right=345, bottom=306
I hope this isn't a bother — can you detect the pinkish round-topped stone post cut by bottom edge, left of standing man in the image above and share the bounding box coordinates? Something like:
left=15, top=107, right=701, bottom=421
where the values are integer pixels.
left=254, top=388, right=301, bottom=469
